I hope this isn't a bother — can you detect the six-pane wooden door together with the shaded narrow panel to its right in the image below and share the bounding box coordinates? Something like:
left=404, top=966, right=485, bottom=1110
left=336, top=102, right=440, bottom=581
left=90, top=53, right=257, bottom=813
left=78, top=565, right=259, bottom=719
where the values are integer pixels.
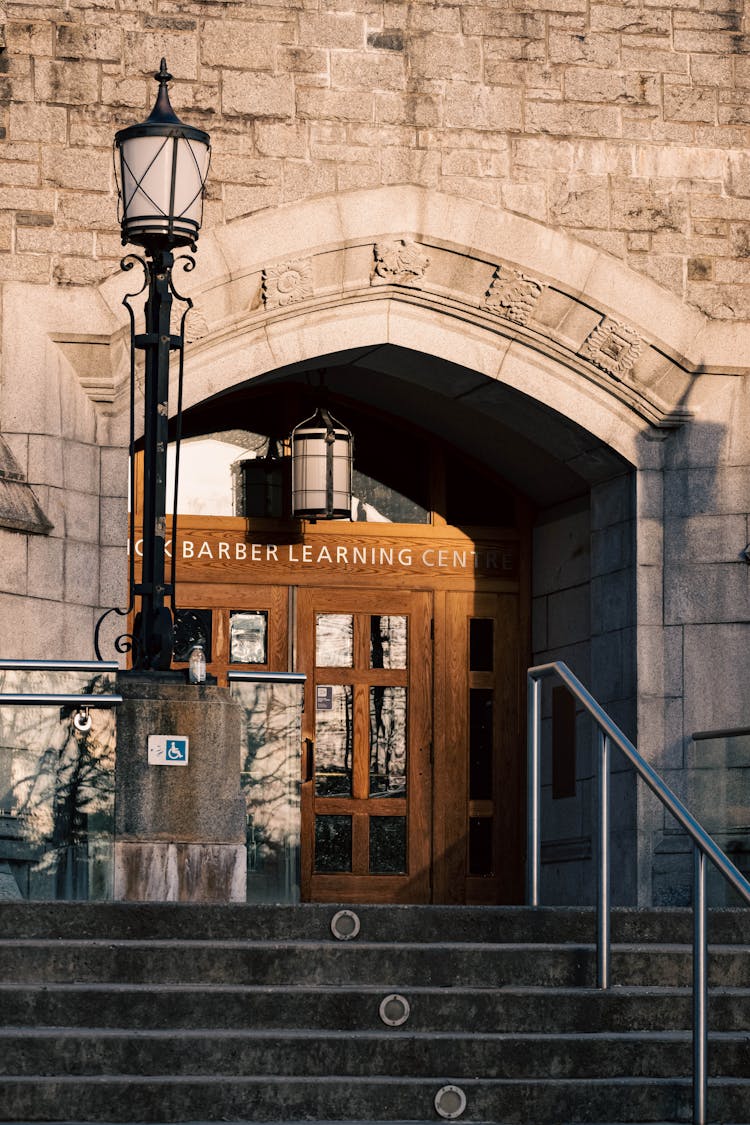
left=295, top=587, right=523, bottom=902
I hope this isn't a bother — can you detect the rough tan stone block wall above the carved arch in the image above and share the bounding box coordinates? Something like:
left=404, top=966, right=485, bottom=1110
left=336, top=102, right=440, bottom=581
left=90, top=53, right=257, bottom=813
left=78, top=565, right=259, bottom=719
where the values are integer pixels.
left=0, top=0, right=750, bottom=318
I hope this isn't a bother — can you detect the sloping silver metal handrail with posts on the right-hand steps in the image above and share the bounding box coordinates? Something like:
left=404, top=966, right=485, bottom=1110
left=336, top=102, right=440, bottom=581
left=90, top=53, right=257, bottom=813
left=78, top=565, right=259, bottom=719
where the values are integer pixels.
left=527, top=660, right=750, bottom=1125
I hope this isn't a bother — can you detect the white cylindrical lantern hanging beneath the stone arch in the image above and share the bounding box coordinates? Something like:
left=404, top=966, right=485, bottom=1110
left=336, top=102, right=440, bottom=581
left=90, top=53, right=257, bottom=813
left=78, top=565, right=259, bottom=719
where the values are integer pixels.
left=291, top=407, right=352, bottom=520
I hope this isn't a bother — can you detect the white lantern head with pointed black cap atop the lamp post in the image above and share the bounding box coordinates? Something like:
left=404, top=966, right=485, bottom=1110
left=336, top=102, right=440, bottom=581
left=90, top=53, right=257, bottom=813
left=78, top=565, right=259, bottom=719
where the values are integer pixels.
left=115, top=59, right=210, bottom=250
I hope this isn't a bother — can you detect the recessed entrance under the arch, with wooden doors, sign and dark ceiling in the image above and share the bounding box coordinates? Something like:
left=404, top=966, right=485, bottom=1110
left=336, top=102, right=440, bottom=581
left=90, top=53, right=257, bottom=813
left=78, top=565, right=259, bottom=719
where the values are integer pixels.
left=132, top=345, right=638, bottom=902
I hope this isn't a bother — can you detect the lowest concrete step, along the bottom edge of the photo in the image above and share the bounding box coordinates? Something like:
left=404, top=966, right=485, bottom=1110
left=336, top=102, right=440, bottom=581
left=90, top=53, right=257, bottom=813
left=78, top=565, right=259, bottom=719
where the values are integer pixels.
left=0, top=1074, right=748, bottom=1125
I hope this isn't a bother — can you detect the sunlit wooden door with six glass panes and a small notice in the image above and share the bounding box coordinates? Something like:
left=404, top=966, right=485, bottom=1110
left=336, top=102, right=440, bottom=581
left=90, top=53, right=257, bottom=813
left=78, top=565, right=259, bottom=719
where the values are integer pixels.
left=297, top=590, right=432, bottom=902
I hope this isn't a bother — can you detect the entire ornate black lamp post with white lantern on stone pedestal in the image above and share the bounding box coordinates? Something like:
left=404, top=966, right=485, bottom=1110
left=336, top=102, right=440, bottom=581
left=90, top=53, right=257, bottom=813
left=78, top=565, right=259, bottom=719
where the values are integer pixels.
left=94, top=59, right=210, bottom=672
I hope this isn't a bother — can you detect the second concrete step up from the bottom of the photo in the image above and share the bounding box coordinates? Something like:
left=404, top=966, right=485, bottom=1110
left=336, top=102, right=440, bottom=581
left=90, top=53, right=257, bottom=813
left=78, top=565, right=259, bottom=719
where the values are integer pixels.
left=0, top=1027, right=748, bottom=1081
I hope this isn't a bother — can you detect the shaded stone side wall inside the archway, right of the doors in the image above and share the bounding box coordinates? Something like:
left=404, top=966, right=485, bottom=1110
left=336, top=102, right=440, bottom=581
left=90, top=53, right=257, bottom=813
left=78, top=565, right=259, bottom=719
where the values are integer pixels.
left=532, top=474, right=638, bottom=905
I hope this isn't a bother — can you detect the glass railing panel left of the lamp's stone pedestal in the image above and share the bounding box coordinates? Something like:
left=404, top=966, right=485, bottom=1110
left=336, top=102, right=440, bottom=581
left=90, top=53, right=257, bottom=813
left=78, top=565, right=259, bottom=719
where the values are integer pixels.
left=0, top=662, right=116, bottom=900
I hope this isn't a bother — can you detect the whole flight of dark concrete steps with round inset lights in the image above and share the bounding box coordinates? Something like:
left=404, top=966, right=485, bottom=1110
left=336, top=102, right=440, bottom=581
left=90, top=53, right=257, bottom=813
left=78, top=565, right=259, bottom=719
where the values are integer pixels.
left=0, top=902, right=750, bottom=1125
